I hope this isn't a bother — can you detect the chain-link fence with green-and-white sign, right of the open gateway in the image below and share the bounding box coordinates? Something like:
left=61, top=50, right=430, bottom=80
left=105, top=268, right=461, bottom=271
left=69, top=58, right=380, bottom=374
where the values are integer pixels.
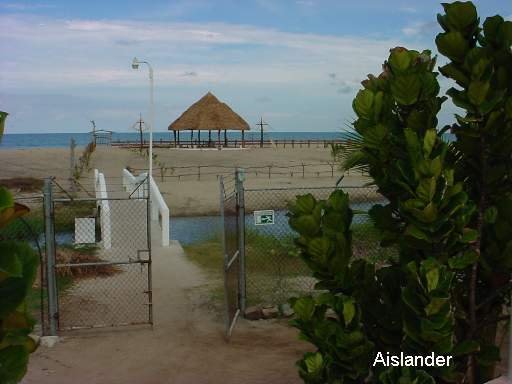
left=244, top=187, right=395, bottom=306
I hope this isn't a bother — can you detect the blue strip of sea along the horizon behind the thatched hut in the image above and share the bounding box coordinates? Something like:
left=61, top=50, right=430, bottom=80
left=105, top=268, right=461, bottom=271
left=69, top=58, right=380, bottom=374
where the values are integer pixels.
left=0, top=131, right=346, bottom=150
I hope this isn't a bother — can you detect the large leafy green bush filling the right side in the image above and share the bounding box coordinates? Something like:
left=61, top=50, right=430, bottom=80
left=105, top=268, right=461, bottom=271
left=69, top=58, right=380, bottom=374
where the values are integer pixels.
left=289, top=2, right=512, bottom=383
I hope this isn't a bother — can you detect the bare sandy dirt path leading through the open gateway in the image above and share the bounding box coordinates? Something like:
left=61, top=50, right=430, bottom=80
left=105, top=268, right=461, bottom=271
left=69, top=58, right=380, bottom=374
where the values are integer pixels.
left=23, top=240, right=310, bottom=384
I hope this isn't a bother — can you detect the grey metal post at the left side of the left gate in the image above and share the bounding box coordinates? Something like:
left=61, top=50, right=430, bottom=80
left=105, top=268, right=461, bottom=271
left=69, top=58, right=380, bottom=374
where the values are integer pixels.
left=42, top=178, right=58, bottom=336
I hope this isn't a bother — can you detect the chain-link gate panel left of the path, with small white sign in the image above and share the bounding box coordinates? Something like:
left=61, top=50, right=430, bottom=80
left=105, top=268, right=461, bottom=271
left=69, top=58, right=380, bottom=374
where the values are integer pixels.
left=45, top=178, right=153, bottom=334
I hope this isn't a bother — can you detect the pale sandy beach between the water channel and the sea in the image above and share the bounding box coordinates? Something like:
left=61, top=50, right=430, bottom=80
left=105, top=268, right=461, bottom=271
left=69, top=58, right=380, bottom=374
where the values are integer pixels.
left=0, top=146, right=368, bottom=216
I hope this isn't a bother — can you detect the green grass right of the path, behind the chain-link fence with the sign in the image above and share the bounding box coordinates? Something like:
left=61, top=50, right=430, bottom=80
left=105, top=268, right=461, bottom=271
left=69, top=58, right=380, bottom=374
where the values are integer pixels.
left=183, top=222, right=397, bottom=305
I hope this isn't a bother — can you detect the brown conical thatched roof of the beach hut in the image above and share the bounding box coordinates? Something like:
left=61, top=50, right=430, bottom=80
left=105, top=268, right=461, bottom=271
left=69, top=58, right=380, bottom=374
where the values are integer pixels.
left=168, top=92, right=250, bottom=131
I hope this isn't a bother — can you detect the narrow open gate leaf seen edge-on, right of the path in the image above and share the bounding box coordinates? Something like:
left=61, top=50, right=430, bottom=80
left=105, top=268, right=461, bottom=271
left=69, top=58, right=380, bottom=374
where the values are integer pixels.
left=220, top=171, right=245, bottom=339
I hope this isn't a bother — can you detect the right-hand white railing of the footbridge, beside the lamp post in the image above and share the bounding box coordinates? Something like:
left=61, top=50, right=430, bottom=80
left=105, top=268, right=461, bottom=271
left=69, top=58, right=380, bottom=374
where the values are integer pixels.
left=123, top=169, right=170, bottom=247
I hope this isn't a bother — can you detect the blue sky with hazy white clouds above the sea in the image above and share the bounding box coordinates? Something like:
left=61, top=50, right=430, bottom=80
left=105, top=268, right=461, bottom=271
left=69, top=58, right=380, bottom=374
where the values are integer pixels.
left=0, top=0, right=512, bottom=133
